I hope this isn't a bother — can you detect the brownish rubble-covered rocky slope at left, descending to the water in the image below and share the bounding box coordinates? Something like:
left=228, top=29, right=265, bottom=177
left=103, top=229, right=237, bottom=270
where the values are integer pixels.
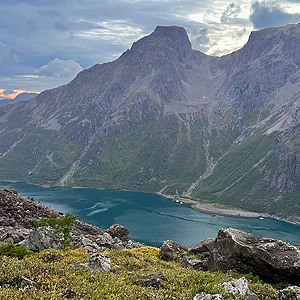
left=0, top=187, right=142, bottom=252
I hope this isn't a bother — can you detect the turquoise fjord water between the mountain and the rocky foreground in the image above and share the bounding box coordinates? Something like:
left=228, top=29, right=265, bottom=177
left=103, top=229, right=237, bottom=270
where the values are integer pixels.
left=0, top=181, right=300, bottom=247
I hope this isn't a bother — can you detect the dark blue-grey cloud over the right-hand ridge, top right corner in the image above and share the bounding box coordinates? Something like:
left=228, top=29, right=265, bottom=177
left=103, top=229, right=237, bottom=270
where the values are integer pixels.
left=250, top=1, right=300, bottom=29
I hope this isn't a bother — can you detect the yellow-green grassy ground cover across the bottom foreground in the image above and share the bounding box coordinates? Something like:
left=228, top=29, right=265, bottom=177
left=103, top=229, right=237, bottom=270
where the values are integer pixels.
left=0, top=247, right=276, bottom=300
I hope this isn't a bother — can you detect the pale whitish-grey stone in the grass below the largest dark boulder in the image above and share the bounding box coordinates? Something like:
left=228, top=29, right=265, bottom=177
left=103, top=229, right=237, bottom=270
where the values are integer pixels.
left=217, top=277, right=259, bottom=300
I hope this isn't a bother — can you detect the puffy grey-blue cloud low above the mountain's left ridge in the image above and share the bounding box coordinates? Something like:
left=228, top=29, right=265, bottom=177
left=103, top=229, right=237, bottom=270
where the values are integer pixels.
left=37, top=58, right=83, bottom=78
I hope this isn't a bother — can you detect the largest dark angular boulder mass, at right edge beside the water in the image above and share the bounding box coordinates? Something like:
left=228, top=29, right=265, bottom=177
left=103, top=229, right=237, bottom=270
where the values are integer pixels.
left=190, top=228, right=300, bottom=283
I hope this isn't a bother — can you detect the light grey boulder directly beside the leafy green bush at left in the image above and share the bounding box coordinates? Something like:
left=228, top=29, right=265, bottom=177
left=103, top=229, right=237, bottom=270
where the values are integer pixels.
left=19, top=226, right=64, bottom=251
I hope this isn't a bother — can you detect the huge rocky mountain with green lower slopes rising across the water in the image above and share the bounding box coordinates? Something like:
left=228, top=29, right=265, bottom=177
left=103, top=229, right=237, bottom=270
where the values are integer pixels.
left=0, top=23, right=300, bottom=216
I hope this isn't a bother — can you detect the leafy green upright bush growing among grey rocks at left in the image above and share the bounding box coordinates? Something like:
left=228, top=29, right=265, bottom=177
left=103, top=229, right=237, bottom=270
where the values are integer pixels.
left=34, top=213, right=77, bottom=248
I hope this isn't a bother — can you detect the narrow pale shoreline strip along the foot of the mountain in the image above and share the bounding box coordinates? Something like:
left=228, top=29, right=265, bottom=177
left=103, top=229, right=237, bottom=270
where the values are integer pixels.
left=0, top=180, right=300, bottom=226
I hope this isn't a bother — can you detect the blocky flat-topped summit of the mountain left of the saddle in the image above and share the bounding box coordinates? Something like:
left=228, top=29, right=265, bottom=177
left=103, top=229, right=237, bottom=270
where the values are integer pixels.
left=127, top=26, right=192, bottom=57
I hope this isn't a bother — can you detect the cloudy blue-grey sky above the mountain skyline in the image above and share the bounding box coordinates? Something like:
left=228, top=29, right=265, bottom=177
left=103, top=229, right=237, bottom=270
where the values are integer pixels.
left=0, top=0, right=300, bottom=100
